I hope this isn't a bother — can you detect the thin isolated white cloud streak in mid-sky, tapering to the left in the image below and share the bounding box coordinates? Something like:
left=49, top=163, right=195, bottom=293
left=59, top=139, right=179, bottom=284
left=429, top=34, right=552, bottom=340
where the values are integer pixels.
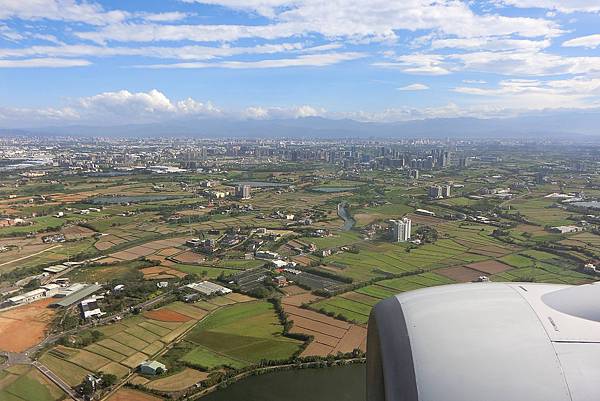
left=136, top=52, right=365, bottom=69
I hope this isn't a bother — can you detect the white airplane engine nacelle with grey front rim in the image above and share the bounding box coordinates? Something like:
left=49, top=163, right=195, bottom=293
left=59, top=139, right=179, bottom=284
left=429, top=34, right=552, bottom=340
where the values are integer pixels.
left=367, top=283, right=600, bottom=401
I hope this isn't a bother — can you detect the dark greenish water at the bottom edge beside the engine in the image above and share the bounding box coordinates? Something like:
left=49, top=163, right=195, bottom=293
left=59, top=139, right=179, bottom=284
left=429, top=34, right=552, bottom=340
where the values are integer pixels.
left=200, top=364, right=366, bottom=401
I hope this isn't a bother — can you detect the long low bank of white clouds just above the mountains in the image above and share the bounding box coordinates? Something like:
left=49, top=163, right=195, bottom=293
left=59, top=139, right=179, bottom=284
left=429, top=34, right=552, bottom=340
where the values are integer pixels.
left=0, top=85, right=600, bottom=128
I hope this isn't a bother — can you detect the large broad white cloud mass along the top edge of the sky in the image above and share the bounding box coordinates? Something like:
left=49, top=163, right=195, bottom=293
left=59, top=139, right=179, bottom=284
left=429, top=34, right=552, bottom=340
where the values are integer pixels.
left=76, top=0, right=562, bottom=43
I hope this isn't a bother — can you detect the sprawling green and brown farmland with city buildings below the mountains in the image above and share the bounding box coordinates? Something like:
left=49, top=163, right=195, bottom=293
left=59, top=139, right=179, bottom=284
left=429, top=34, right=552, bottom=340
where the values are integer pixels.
left=0, top=137, right=600, bottom=401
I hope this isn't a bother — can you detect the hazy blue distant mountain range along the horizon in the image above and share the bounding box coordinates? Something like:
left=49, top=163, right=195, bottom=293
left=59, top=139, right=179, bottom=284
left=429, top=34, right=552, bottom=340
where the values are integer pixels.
left=0, top=110, right=600, bottom=138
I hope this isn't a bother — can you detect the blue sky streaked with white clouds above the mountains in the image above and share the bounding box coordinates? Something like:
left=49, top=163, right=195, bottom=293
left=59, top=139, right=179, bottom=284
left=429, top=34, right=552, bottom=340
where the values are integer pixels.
left=0, top=0, right=600, bottom=128
